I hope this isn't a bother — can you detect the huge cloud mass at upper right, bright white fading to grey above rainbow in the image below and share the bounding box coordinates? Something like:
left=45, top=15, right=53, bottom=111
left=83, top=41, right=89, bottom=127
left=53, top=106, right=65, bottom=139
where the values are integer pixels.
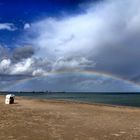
left=21, top=0, right=140, bottom=82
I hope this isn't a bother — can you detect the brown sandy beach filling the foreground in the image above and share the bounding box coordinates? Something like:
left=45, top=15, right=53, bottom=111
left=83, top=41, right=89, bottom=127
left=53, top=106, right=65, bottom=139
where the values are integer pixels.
left=0, top=96, right=140, bottom=140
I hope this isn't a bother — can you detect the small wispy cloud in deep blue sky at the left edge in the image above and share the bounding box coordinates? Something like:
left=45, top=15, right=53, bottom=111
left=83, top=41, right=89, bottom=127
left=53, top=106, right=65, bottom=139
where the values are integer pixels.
left=0, top=23, right=17, bottom=31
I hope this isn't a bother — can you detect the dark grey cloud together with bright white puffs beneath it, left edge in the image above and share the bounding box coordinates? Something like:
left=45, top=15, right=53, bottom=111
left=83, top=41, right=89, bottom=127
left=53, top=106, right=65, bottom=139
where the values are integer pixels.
left=0, top=46, right=47, bottom=76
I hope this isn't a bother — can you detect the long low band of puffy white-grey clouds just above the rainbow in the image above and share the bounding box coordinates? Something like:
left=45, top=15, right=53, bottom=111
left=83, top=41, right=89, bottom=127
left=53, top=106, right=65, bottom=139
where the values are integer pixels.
left=0, top=56, right=95, bottom=77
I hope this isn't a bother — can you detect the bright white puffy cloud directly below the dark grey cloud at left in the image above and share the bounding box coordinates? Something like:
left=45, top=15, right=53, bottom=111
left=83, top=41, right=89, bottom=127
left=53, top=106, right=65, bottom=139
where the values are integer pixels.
left=0, top=57, right=52, bottom=76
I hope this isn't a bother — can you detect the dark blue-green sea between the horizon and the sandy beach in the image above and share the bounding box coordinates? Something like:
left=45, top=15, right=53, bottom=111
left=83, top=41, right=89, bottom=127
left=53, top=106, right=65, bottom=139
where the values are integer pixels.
left=1, top=92, right=140, bottom=107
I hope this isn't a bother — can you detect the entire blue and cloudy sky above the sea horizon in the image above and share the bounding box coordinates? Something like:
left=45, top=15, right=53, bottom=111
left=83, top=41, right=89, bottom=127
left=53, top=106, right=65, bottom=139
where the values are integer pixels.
left=0, top=0, right=140, bottom=91
